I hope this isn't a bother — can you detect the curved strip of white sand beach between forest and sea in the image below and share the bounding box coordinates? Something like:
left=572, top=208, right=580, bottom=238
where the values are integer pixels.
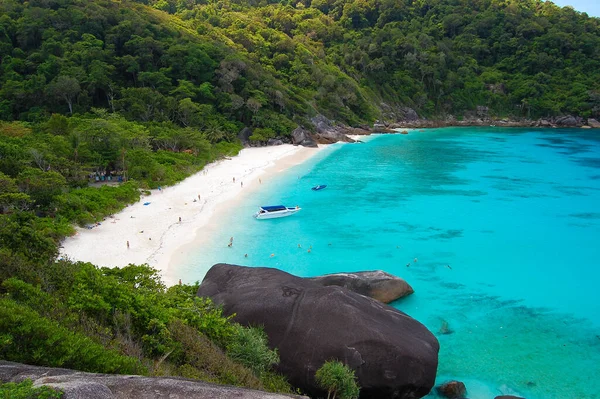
left=61, top=144, right=323, bottom=285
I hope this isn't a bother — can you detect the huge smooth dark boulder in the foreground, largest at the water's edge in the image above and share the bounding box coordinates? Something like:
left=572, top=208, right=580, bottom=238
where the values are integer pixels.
left=198, top=264, right=439, bottom=398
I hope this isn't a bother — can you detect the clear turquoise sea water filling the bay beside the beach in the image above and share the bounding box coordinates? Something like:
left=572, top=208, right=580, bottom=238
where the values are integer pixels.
left=181, top=128, right=600, bottom=399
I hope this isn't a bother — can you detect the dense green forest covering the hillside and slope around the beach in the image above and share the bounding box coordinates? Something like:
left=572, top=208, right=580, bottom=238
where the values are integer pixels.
left=0, top=0, right=600, bottom=392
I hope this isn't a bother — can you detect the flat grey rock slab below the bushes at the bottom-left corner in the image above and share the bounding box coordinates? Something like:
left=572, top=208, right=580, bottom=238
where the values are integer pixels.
left=0, top=361, right=305, bottom=399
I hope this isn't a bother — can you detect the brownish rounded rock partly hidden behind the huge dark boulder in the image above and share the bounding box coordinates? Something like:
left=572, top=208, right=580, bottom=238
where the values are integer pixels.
left=309, top=270, right=415, bottom=303
